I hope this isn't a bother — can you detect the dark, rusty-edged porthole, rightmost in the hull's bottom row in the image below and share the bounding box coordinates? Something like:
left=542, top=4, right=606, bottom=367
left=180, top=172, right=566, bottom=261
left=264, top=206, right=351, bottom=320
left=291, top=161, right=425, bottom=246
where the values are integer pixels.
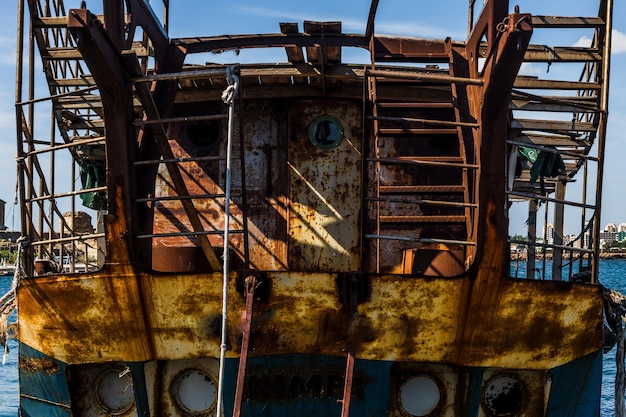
left=482, top=375, right=526, bottom=417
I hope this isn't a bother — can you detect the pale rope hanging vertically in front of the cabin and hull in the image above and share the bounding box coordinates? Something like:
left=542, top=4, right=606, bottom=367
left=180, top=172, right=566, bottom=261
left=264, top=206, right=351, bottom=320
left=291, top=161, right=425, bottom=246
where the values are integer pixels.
left=216, top=66, right=239, bottom=417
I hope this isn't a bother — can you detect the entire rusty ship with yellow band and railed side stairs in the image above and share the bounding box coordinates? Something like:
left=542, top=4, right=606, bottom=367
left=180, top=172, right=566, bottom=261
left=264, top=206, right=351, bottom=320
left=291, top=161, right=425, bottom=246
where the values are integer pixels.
left=0, top=0, right=613, bottom=417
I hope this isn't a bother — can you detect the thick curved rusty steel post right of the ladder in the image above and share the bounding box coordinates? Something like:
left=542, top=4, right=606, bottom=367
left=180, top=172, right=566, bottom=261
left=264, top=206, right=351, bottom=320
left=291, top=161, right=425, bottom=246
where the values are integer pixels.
left=455, top=13, right=532, bottom=360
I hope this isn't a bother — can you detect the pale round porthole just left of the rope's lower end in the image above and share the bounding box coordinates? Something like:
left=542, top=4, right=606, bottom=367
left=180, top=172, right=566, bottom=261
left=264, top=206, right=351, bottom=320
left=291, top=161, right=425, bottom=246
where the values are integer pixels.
left=171, top=368, right=217, bottom=416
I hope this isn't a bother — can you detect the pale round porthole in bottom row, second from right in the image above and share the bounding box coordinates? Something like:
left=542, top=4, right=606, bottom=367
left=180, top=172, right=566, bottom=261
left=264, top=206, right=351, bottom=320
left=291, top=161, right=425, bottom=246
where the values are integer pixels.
left=400, top=375, right=445, bottom=417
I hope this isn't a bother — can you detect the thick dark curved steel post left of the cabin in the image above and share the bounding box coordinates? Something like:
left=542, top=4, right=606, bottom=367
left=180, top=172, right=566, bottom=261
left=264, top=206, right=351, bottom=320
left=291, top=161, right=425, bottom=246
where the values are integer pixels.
left=68, top=9, right=139, bottom=257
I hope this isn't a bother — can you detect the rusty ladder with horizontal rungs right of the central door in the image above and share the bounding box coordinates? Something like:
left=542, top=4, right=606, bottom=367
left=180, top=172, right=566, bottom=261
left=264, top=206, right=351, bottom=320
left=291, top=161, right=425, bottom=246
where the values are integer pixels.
left=364, top=58, right=480, bottom=273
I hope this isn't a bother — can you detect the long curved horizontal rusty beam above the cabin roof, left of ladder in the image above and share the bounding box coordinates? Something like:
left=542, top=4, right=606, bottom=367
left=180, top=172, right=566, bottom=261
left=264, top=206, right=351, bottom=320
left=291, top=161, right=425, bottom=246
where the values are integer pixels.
left=171, top=33, right=368, bottom=54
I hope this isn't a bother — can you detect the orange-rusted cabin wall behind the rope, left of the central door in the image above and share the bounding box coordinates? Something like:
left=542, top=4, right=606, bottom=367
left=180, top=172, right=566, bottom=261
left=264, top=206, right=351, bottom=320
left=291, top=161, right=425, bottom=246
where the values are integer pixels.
left=153, top=100, right=287, bottom=272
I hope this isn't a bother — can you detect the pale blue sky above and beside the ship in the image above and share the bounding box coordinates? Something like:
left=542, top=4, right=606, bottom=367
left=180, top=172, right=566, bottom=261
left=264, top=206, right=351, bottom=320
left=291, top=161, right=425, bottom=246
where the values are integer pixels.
left=0, top=0, right=626, bottom=232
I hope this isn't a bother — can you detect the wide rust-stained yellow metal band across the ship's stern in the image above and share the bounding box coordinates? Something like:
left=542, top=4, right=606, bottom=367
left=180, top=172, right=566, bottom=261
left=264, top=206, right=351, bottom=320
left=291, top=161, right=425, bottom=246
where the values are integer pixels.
left=19, top=273, right=602, bottom=369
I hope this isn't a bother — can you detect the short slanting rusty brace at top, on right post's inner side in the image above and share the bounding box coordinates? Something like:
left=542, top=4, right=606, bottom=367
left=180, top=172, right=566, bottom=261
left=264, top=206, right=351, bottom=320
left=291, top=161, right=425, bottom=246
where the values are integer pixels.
left=466, top=0, right=509, bottom=78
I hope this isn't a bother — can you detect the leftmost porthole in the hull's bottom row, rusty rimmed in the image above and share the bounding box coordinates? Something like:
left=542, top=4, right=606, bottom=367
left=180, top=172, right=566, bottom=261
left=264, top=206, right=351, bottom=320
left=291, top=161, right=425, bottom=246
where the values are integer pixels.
left=94, top=368, right=135, bottom=416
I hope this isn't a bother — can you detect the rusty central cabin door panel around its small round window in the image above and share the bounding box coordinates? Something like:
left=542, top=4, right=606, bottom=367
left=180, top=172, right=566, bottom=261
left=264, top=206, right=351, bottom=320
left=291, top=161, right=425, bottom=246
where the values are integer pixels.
left=288, top=100, right=362, bottom=271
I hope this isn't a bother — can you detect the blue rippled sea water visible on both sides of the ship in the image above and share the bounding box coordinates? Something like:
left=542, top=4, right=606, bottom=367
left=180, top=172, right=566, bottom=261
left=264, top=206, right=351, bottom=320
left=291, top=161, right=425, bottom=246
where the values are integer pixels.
left=0, top=259, right=626, bottom=417
